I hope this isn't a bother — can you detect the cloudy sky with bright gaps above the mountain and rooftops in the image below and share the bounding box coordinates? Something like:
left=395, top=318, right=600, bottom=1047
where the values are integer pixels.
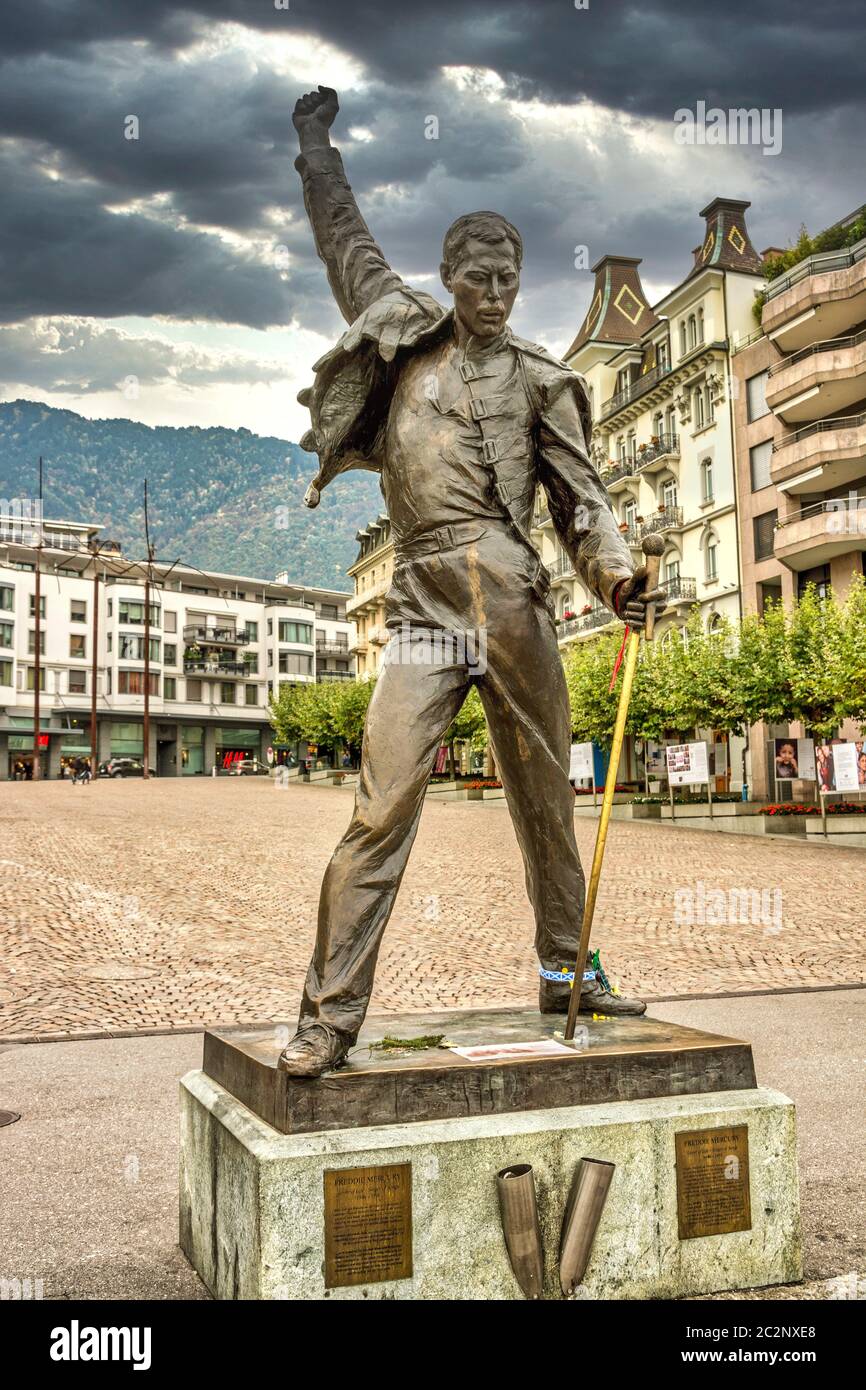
left=0, top=0, right=866, bottom=439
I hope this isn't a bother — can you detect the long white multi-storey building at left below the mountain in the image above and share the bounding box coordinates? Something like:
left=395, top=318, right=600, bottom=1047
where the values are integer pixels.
left=0, top=517, right=353, bottom=777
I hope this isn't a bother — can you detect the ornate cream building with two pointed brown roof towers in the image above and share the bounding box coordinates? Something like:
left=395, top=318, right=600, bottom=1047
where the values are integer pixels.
left=535, top=197, right=763, bottom=646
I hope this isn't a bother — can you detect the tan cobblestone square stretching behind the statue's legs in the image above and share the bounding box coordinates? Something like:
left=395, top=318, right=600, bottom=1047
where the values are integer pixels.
left=0, top=778, right=866, bottom=1037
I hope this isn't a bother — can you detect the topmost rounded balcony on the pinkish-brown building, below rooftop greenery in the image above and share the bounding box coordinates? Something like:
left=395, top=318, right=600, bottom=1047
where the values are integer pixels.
left=760, top=240, right=866, bottom=352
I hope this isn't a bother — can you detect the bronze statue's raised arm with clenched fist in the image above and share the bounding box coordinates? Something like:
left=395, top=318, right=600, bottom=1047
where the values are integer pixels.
left=292, top=86, right=403, bottom=322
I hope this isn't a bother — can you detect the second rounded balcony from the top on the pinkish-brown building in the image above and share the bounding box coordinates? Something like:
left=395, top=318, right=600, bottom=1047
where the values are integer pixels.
left=766, top=329, right=866, bottom=423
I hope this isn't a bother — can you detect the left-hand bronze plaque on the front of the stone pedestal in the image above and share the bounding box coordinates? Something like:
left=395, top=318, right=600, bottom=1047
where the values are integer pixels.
left=324, top=1163, right=411, bottom=1289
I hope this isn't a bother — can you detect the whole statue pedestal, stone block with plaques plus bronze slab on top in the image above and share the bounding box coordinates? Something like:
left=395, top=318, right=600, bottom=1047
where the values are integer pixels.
left=181, top=1011, right=801, bottom=1300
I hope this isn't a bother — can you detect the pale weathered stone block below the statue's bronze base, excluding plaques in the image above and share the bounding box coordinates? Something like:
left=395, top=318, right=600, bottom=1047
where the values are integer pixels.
left=181, top=1072, right=802, bottom=1300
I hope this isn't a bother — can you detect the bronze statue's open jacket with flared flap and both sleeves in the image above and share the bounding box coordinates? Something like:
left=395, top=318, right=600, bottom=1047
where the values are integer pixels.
left=296, top=146, right=634, bottom=607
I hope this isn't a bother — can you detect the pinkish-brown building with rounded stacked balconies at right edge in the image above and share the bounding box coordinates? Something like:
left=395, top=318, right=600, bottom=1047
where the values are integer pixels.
left=733, top=207, right=866, bottom=796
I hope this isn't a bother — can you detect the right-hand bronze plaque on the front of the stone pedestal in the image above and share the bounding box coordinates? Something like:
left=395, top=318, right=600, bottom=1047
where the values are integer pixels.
left=674, top=1125, right=752, bottom=1240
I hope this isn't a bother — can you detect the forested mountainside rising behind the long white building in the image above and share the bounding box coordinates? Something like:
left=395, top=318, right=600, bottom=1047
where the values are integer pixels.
left=0, top=400, right=385, bottom=591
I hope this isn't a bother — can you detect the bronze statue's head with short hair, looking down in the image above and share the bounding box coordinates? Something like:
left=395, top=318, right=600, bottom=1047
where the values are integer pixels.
left=439, top=213, right=523, bottom=338
